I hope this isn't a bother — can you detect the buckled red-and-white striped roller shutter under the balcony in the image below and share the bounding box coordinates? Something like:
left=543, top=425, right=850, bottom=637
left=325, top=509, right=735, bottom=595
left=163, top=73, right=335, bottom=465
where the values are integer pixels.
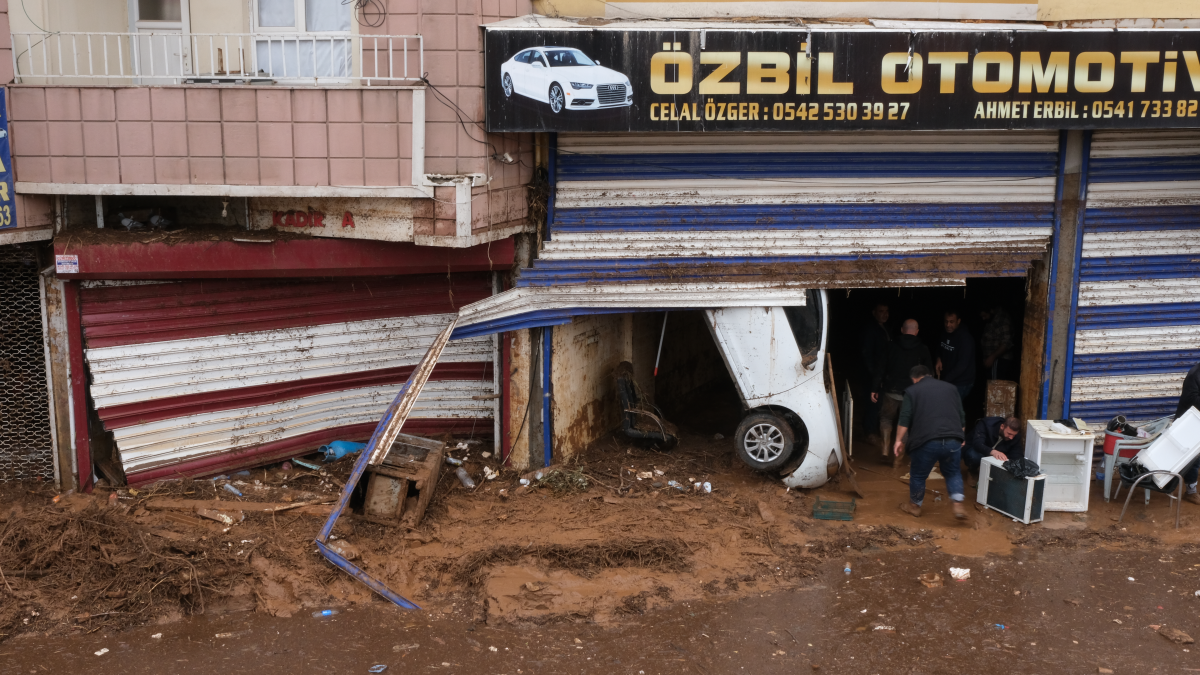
left=82, top=273, right=493, bottom=484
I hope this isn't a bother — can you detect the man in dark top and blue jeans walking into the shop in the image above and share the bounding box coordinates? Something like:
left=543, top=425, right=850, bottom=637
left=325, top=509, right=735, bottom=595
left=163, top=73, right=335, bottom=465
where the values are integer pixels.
left=892, top=365, right=967, bottom=520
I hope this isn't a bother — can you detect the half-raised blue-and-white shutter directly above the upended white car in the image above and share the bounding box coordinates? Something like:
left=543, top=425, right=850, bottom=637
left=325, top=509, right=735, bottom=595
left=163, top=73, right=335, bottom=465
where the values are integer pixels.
left=517, top=132, right=1058, bottom=288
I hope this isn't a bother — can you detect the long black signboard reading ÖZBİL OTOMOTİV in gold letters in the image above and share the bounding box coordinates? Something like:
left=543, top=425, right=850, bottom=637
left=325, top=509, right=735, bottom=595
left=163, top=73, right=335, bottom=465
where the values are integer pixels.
left=485, top=28, right=1200, bottom=131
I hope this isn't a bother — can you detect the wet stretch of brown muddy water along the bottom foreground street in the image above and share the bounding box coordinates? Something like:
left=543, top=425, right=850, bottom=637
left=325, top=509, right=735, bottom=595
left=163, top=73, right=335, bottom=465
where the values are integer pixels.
left=0, top=549, right=1200, bottom=675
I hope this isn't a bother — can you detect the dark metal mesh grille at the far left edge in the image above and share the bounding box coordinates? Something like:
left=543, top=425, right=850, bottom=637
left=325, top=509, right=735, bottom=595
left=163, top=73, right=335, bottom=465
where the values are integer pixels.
left=0, top=245, right=54, bottom=482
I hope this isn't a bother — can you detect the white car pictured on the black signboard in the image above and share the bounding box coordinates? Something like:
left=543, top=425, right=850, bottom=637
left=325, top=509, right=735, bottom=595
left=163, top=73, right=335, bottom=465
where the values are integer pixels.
left=500, top=47, right=634, bottom=113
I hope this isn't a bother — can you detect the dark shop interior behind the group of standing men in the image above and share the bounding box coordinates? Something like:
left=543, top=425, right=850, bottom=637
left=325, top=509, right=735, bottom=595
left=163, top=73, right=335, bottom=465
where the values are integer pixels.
left=829, top=277, right=1038, bottom=444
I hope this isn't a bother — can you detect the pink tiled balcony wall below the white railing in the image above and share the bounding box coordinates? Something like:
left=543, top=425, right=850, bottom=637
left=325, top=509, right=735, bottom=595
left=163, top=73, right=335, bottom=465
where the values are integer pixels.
left=10, top=85, right=413, bottom=186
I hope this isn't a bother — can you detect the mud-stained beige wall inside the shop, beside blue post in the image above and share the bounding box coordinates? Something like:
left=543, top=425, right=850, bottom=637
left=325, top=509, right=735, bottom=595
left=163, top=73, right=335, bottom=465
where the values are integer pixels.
left=551, top=315, right=628, bottom=464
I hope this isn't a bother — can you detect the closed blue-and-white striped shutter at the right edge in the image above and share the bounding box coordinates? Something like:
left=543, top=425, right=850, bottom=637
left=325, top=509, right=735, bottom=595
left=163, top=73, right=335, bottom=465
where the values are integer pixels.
left=1069, top=131, right=1200, bottom=422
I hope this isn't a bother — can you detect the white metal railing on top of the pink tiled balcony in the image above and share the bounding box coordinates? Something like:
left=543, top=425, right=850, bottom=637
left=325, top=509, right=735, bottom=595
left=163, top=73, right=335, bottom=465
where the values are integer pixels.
left=12, top=31, right=425, bottom=86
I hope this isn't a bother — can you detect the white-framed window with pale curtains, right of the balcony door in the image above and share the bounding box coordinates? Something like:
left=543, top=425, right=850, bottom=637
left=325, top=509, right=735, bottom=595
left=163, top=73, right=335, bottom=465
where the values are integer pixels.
left=250, top=0, right=353, bottom=79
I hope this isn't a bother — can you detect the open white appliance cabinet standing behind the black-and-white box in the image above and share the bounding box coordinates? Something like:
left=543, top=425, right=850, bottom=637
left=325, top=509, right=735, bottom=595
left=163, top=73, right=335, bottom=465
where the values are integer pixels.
left=1025, top=419, right=1096, bottom=512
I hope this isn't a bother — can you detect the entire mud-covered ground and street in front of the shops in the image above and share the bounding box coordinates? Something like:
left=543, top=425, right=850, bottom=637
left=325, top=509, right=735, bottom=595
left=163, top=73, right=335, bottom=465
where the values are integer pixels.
left=0, top=427, right=1200, bottom=673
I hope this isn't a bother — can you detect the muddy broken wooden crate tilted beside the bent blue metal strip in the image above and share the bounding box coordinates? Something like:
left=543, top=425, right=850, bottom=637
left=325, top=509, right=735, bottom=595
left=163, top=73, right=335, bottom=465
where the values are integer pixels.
left=362, top=434, right=445, bottom=527
